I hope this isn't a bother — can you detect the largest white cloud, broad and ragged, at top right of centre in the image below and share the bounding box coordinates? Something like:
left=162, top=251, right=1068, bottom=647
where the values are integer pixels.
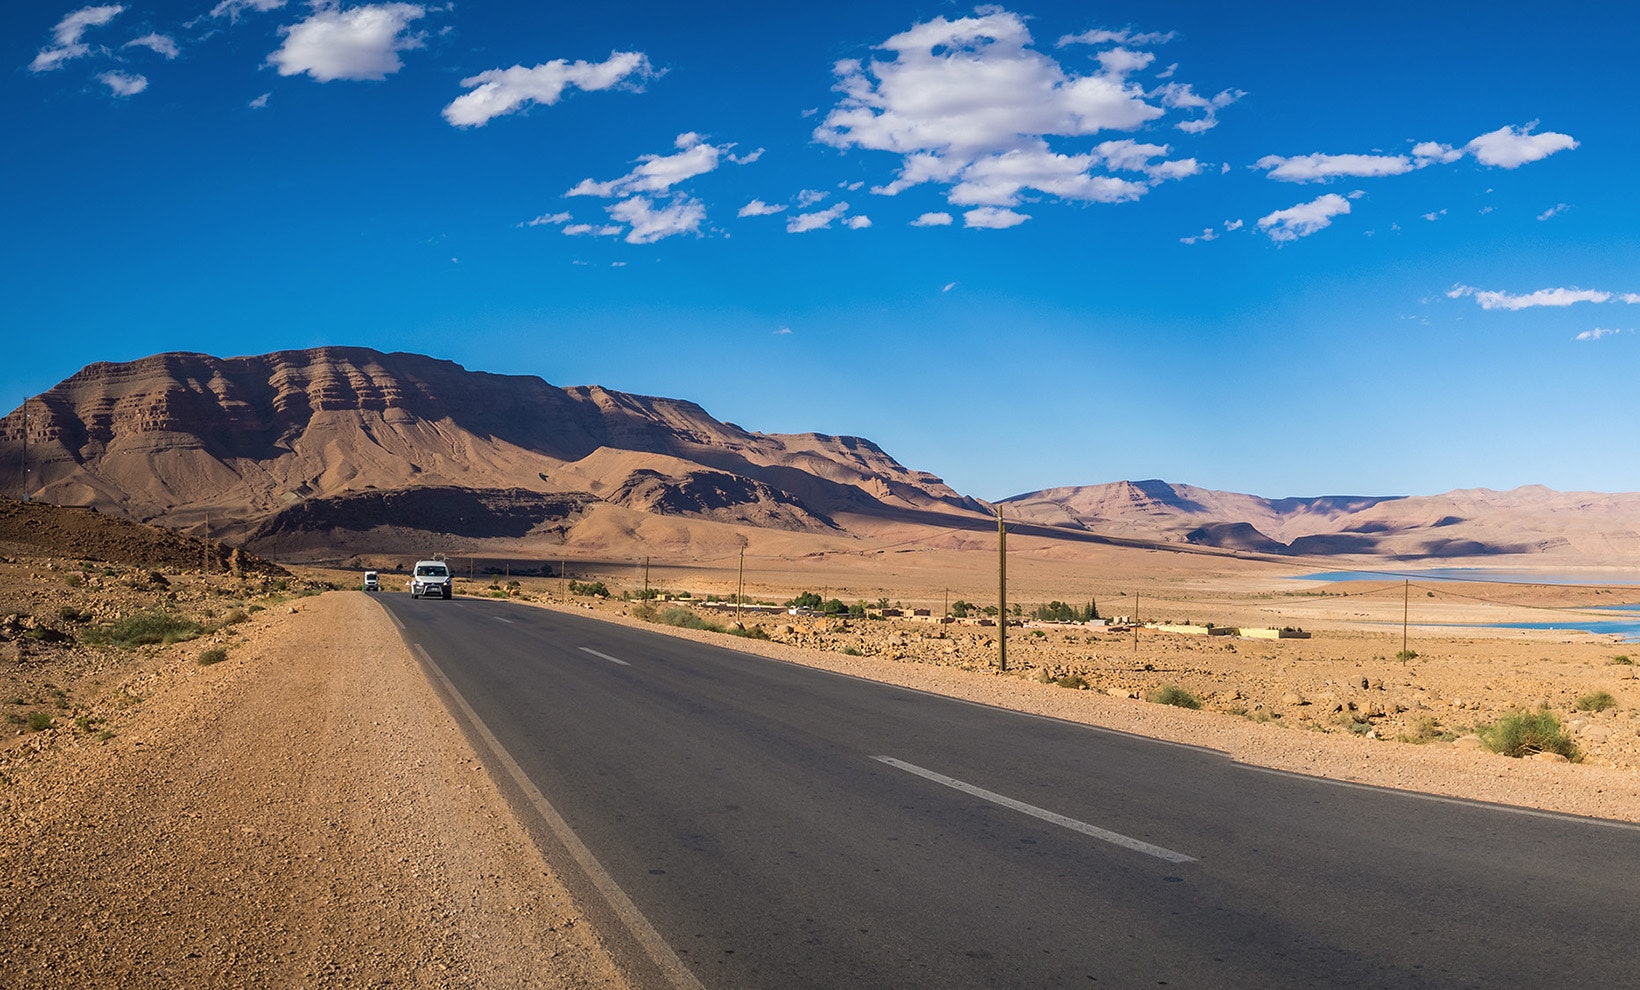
left=815, top=7, right=1235, bottom=226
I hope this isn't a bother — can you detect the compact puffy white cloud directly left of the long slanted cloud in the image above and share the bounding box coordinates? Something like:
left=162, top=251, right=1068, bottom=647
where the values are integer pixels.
left=267, top=0, right=426, bottom=82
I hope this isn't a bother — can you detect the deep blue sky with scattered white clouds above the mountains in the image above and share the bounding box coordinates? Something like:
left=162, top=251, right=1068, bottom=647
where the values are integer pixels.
left=0, top=0, right=1640, bottom=498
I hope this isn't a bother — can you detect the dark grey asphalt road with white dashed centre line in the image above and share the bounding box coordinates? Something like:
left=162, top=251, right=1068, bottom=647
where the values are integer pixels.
left=380, top=595, right=1640, bottom=988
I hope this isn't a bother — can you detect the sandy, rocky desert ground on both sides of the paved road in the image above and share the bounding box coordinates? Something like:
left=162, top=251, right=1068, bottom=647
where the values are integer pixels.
left=0, top=501, right=1640, bottom=987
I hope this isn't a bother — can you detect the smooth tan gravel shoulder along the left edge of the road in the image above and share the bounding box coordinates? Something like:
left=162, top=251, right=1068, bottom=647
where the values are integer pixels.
left=0, top=593, right=625, bottom=990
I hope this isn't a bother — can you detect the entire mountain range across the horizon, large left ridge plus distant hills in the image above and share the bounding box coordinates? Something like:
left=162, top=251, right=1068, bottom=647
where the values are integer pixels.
left=0, top=347, right=1640, bottom=562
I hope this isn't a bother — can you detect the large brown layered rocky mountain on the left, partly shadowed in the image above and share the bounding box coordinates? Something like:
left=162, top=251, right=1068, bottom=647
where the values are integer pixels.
left=0, top=347, right=986, bottom=554
